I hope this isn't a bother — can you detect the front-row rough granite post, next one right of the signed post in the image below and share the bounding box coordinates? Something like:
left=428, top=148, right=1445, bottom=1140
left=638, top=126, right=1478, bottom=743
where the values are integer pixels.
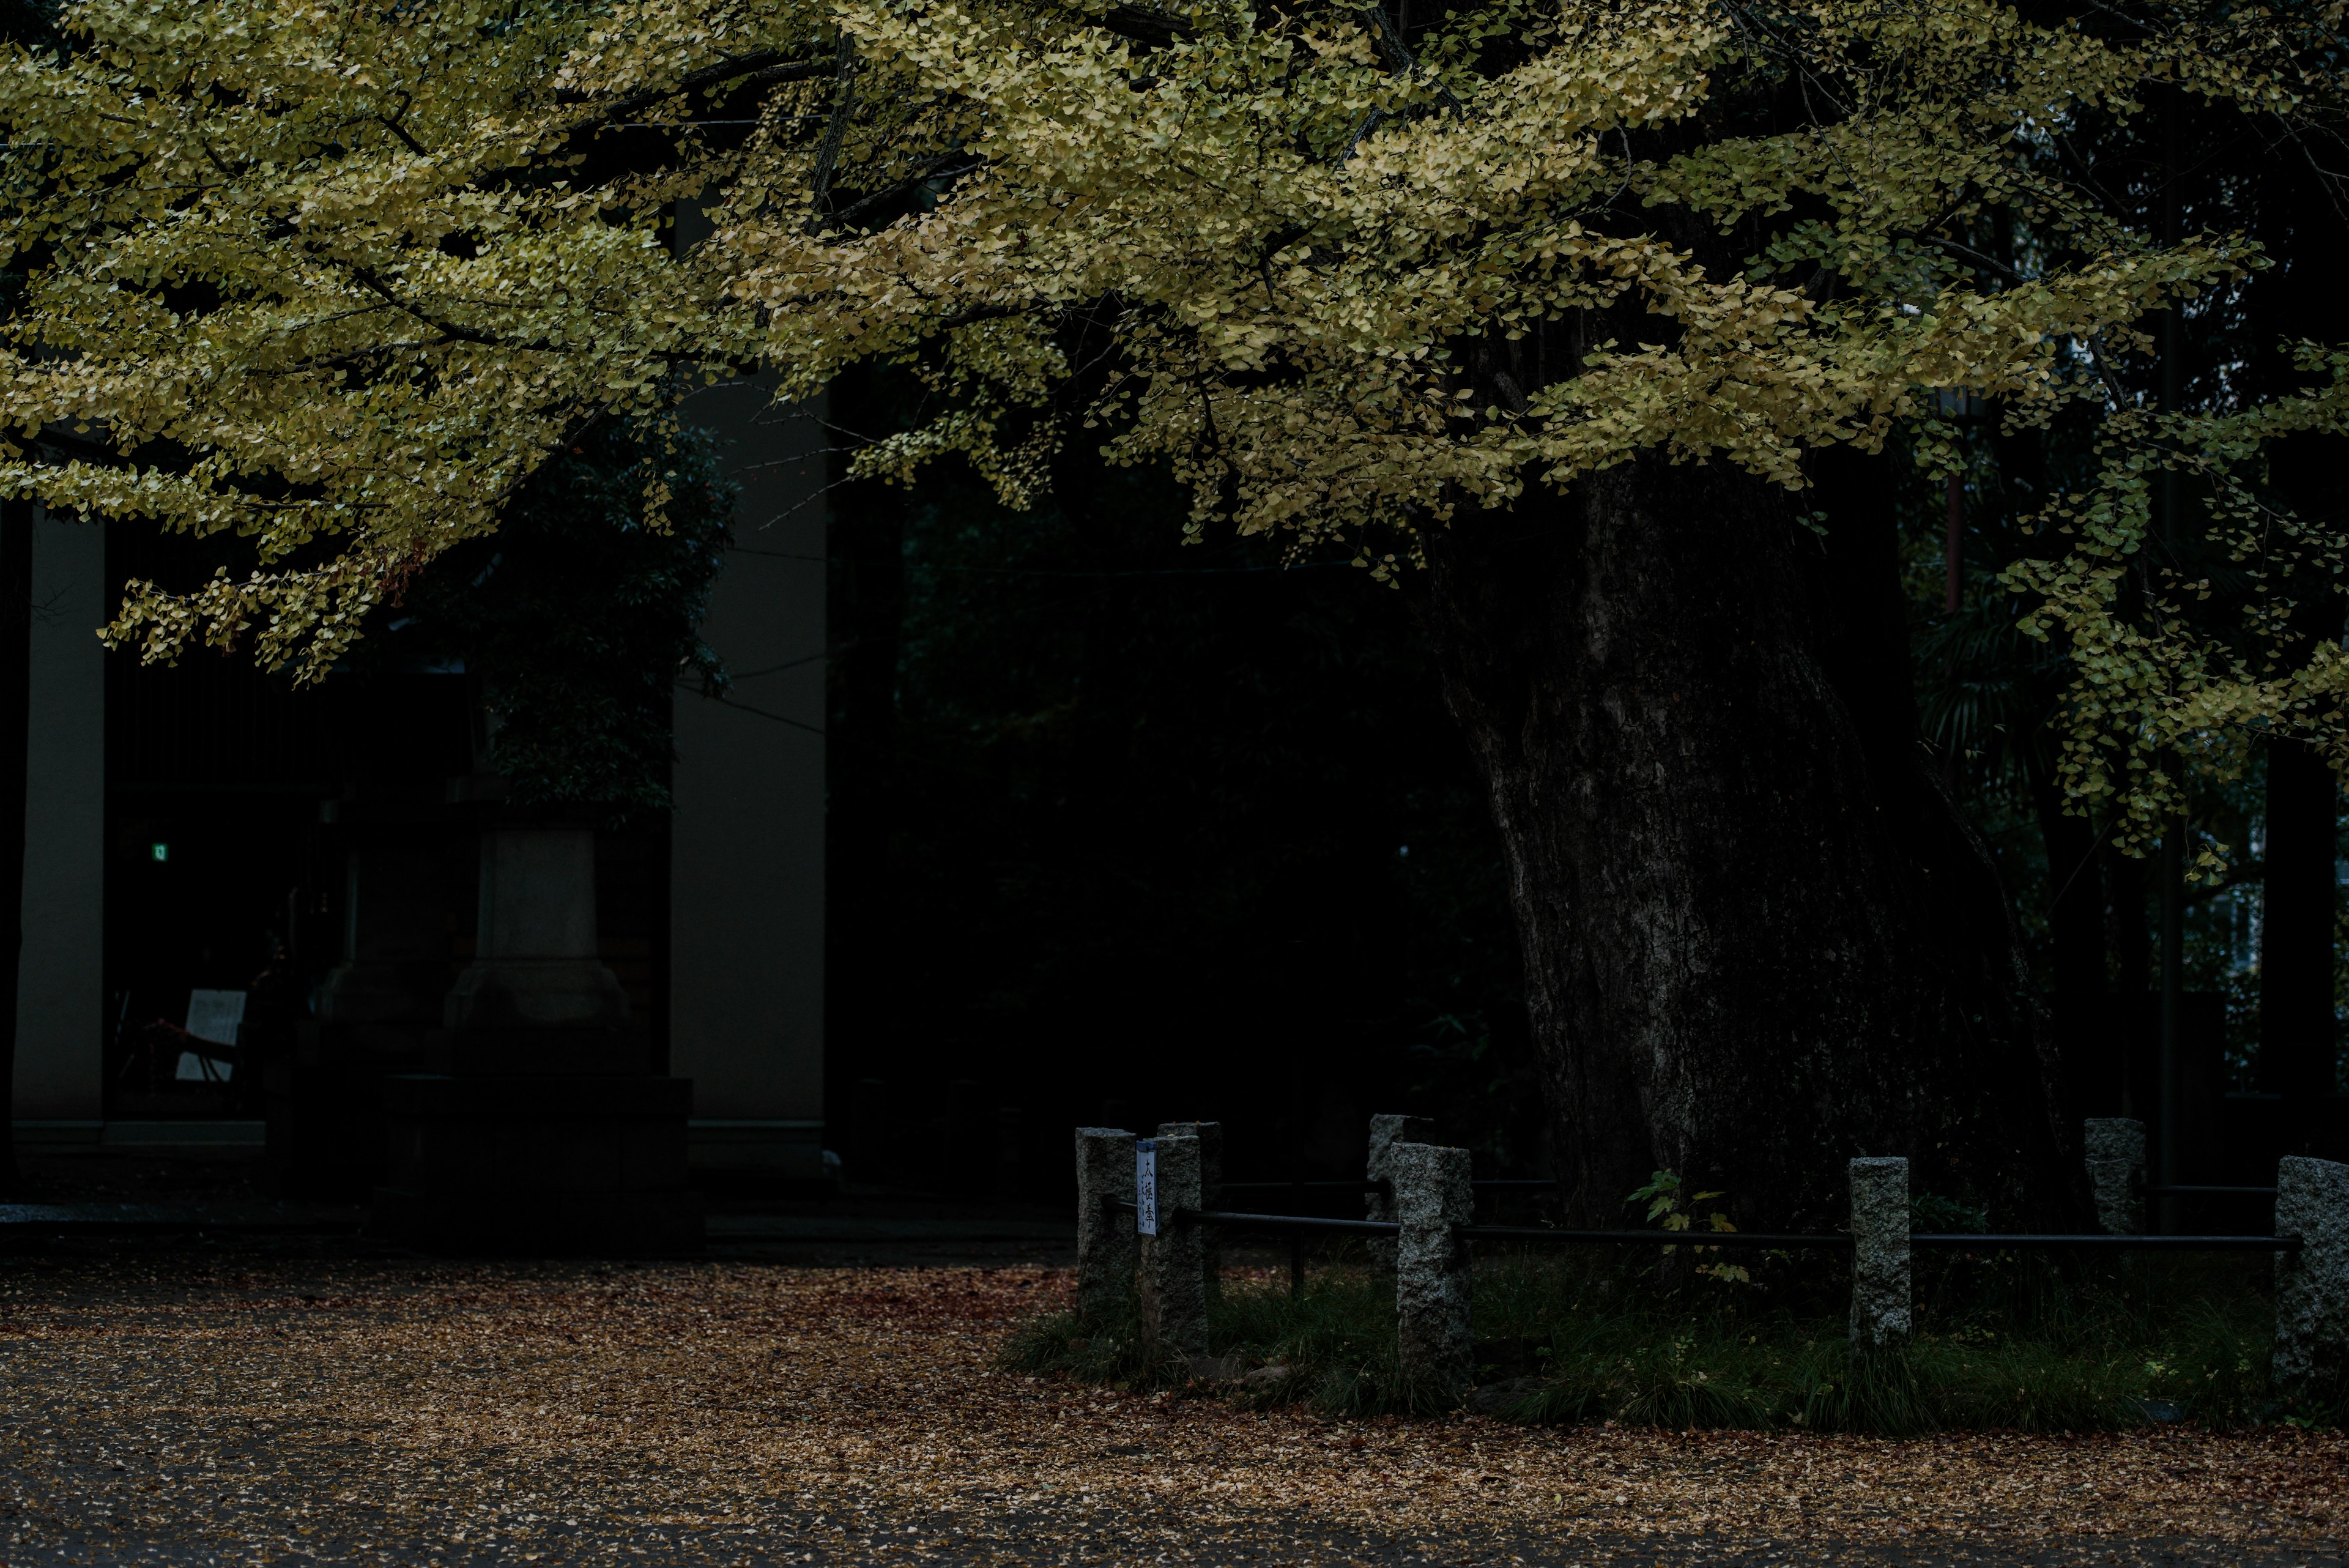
left=1386, top=1142, right=1475, bottom=1406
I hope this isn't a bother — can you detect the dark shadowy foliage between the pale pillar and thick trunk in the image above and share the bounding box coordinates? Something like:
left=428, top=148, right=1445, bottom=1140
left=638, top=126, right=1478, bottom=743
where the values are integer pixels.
left=829, top=376, right=1543, bottom=1175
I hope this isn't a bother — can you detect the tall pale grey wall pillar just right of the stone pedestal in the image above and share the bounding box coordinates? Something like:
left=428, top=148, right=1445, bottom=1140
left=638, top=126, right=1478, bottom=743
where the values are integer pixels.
left=669, top=381, right=825, bottom=1175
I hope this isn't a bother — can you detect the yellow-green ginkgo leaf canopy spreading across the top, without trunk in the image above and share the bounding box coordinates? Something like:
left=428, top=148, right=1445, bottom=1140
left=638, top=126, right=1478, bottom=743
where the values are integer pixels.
left=0, top=0, right=2349, bottom=837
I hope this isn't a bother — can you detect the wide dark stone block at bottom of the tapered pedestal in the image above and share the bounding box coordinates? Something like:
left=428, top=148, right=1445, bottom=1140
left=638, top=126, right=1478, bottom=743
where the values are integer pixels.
left=376, top=1074, right=702, bottom=1253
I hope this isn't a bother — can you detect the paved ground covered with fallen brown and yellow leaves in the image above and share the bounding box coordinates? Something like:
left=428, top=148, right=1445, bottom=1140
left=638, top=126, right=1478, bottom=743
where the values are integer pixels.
left=0, top=1255, right=2349, bottom=1568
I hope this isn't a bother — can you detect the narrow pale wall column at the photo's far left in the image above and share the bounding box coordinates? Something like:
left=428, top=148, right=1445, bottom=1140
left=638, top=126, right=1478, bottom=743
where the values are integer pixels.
left=17, top=513, right=108, bottom=1121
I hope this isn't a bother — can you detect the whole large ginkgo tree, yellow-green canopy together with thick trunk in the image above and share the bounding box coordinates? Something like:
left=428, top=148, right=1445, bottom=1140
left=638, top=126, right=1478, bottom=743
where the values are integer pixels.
left=0, top=0, right=2349, bottom=1222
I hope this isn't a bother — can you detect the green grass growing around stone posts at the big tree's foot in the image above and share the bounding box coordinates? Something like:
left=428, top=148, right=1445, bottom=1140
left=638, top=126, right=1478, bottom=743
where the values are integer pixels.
left=1006, top=1250, right=2344, bottom=1434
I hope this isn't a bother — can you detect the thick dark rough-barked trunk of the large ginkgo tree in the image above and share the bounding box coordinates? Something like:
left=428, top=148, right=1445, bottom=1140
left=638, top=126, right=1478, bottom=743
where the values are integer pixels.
left=1423, top=447, right=2084, bottom=1227
